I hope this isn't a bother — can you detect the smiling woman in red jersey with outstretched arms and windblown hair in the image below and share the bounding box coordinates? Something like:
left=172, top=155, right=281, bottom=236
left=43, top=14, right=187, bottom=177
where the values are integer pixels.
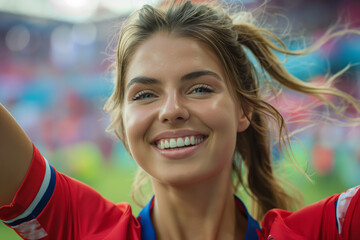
left=0, top=1, right=360, bottom=239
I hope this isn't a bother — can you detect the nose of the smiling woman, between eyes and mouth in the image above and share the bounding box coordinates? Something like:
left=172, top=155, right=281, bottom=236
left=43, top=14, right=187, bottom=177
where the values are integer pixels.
left=159, top=93, right=190, bottom=123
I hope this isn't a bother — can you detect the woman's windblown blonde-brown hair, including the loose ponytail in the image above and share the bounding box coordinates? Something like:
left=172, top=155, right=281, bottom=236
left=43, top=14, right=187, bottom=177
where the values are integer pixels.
left=104, top=1, right=360, bottom=219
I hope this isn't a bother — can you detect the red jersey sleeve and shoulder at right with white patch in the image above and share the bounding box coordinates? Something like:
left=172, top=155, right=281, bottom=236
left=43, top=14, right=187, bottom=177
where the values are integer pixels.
left=261, top=186, right=360, bottom=240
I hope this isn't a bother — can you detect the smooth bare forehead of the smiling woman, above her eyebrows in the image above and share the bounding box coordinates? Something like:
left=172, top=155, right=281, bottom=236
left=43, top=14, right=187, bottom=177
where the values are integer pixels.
left=125, top=33, right=224, bottom=83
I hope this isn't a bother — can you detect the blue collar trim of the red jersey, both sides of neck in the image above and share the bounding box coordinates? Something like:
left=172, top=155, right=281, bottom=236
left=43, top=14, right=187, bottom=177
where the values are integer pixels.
left=138, top=196, right=260, bottom=240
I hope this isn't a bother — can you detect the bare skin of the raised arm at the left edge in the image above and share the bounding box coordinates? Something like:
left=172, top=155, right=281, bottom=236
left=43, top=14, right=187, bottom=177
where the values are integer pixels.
left=0, top=103, right=33, bottom=206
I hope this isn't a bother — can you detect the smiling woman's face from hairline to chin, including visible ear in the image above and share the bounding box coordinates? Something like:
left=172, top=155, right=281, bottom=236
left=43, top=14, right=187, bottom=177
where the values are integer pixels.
left=123, top=33, right=248, bottom=185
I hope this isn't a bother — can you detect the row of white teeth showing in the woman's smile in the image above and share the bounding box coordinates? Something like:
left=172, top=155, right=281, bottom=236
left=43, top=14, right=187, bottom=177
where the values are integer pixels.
left=155, top=135, right=207, bottom=150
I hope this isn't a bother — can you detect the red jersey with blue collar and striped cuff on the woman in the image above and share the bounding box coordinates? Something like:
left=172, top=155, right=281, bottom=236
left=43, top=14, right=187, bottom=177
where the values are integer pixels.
left=0, top=143, right=360, bottom=240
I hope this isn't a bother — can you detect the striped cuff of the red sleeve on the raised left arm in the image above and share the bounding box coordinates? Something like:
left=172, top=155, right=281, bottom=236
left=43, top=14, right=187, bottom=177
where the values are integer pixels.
left=0, top=143, right=56, bottom=239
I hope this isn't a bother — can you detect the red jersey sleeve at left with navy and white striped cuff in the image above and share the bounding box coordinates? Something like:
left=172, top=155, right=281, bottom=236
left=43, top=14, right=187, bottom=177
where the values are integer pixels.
left=0, top=143, right=140, bottom=240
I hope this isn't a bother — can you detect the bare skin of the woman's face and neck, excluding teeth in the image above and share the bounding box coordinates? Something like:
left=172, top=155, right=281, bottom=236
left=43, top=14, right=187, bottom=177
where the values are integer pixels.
left=123, top=33, right=249, bottom=239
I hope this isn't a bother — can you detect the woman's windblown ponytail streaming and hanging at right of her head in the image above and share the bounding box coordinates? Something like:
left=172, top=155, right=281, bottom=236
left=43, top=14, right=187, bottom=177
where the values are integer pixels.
left=233, top=23, right=360, bottom=219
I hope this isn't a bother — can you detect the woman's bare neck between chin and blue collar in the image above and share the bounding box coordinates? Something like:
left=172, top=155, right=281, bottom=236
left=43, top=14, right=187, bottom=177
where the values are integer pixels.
left=152, top=169, right=247, bottom=240
